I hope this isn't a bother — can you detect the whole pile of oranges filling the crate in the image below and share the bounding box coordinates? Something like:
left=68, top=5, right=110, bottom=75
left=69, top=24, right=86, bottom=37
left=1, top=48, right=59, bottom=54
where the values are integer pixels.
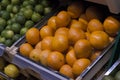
left=19, top=2, right=120, bottom=79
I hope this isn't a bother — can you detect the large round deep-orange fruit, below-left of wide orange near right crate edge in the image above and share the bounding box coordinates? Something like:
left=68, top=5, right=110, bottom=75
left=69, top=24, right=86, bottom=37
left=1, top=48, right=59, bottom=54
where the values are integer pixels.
left=74, top=39, right=93, bottom=58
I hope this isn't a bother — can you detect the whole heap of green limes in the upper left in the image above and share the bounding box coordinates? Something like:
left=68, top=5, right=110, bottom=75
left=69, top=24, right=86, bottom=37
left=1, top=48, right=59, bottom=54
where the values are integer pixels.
left=0, top=0, right=55, bottom=46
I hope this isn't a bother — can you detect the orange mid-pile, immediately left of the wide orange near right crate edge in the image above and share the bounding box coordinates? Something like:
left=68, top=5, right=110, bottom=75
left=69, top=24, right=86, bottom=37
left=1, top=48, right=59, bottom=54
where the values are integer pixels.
left=68, top=28, right=86, bottom=45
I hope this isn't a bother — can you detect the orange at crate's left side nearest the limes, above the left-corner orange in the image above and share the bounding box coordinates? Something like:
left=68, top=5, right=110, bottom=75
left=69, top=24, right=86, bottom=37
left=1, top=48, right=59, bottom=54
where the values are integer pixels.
left=25, top=27, right=40, bottom=45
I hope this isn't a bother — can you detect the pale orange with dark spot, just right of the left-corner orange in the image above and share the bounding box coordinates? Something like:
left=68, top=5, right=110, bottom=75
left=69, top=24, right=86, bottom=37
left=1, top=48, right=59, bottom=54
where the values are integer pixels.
left=29, top=49, right=41, bottom=62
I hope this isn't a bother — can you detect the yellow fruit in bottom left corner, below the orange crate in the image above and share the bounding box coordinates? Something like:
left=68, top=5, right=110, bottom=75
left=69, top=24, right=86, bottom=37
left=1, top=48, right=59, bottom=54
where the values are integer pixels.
left=4, top=64, right=20, bottom=78
